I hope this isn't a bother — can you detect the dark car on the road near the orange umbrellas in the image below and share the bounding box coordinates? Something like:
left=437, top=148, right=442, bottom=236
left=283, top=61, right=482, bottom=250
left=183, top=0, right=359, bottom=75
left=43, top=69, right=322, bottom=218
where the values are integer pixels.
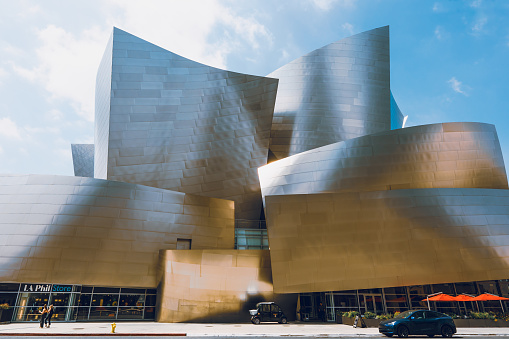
left=378, top=310, right=456, bottom=338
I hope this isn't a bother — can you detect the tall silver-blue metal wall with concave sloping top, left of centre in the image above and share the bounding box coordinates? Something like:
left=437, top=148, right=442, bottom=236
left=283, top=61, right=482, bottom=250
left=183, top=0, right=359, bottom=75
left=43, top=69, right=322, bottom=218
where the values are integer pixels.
left=98, top=28, right=278, bottom=219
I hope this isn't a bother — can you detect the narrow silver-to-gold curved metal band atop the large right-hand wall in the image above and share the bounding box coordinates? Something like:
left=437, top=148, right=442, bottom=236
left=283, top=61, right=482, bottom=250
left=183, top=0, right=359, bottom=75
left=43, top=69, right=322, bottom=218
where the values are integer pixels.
left=258, top=122, right=508, bottom=198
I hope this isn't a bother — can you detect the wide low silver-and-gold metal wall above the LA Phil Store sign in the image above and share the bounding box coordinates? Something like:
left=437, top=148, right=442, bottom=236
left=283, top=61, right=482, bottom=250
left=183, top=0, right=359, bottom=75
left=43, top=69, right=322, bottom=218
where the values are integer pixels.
left=0, top=175, right=234, bottom=287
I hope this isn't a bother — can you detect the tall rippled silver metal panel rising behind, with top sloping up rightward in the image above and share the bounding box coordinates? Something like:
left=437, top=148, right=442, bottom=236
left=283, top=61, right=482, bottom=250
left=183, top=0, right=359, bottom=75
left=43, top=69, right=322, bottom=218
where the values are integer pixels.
left=268, top=26, right=391, bottom=159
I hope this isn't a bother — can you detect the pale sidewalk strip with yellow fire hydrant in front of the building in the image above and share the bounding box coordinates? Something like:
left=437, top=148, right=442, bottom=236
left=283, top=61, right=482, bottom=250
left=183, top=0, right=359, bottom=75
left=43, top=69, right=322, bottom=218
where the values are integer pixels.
left=0, top=322, right=509, bottom=337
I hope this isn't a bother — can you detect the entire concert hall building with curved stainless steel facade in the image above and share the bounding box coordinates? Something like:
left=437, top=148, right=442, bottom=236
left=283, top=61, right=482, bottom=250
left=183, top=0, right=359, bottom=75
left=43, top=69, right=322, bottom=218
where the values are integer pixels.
left=0, top=27, right=509, bottom=322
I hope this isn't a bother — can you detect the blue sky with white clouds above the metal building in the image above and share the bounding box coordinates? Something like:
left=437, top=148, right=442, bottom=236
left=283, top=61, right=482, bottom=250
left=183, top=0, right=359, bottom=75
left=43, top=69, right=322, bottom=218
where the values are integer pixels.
left=0, top=0, right=509, bottom=175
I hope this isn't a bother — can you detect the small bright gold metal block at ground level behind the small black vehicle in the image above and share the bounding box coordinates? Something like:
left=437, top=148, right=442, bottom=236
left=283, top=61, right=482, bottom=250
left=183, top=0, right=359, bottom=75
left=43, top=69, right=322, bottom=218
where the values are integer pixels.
left=157, top=250, right=297, bottom=322
